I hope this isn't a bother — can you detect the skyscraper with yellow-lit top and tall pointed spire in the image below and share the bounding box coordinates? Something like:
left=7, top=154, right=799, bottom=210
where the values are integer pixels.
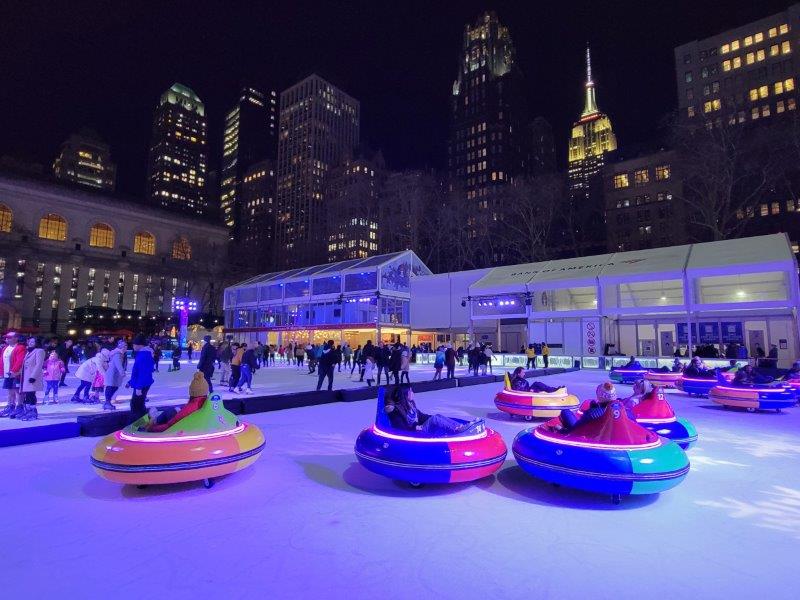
left=564, top=46, right=617, bottom=255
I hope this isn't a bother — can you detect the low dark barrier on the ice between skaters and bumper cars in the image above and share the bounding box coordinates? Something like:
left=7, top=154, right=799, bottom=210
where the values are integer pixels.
left=6, top=368, right=578, bottom=447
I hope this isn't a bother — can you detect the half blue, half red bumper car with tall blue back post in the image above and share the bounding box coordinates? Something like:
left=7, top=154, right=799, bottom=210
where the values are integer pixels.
left=355, top=388, right=508, bottom=486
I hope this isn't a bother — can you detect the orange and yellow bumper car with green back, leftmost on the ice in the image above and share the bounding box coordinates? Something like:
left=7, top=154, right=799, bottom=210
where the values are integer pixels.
left=91, top=394, right=265, bottom=487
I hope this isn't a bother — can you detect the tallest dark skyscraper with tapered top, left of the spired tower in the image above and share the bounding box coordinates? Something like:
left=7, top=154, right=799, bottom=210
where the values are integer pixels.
left=447, top=12, right=533, bottom=266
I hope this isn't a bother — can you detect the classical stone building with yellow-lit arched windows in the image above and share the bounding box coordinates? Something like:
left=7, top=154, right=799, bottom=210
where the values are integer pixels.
left=0, top=173, right=230, bottom=333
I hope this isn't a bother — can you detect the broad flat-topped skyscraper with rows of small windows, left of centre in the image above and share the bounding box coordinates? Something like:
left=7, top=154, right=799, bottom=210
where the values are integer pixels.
left=275, top=75, right=360, bottom=268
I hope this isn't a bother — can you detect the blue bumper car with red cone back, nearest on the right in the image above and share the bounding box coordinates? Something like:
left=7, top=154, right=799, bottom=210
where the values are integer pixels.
left=512, top=402, right=689, bottom=503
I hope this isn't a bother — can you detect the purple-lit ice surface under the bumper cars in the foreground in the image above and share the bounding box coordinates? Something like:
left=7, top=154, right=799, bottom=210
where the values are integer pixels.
left=0, top=371, right=800, bottom=600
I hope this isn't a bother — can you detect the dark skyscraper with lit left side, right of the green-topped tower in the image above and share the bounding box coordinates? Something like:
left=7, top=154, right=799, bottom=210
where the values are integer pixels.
left=220, top=86, right=278, bottom=240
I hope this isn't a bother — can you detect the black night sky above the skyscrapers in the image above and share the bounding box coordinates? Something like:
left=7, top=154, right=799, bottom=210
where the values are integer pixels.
left=0, top=0, right=788, bottom=195
